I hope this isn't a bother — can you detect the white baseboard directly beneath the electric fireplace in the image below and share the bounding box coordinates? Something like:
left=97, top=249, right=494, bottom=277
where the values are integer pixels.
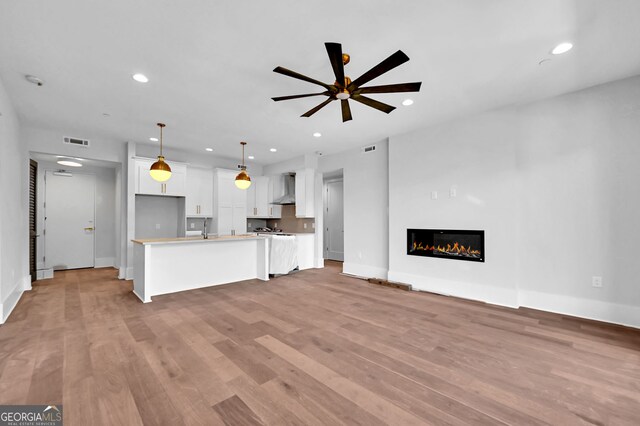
left=389, top=271, right=518, bottom=308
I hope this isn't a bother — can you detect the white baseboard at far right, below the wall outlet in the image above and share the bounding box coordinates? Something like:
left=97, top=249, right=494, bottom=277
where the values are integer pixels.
left=519, top=290, right=640, bottom=328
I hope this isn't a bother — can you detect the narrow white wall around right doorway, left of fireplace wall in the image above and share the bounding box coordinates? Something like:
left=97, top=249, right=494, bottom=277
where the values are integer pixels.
left=316, top=141, right=389, bottom=278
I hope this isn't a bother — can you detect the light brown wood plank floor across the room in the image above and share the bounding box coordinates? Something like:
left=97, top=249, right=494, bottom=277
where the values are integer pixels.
left=0, top=264, right=640, bottom=426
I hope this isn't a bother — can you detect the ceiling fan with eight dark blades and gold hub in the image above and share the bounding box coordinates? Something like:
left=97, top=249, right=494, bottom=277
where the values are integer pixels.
left=271, top=43, right=422, bottom=122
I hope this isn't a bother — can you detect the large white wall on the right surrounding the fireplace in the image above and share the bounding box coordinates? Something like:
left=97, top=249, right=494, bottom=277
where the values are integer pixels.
left=389, top=77, right=640, bottom=326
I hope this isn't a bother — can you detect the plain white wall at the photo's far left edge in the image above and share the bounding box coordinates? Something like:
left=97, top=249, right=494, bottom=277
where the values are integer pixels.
left=0, top=75, right=31, bottom=323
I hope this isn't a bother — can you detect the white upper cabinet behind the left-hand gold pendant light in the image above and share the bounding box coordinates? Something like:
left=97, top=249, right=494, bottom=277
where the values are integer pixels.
left=135, top=158, right=187, bottom=197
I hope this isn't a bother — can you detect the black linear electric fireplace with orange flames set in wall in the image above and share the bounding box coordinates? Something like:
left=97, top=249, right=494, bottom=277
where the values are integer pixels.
left=407, top=229, right=485, bottom=262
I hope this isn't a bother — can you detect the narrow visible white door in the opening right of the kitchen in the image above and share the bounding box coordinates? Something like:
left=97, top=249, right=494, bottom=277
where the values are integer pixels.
left=325, top=181, right=344, bottom=261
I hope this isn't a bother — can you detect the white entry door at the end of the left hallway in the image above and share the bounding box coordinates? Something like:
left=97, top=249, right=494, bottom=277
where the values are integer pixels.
left=44, top=171, right=96, bottom=270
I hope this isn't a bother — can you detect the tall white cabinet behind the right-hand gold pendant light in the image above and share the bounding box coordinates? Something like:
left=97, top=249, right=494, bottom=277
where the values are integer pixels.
left=213, top=169, right=247, bottom=235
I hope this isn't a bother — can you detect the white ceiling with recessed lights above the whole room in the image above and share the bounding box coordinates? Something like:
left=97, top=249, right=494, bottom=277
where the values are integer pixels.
left=0, top=0, right=640, bottom=164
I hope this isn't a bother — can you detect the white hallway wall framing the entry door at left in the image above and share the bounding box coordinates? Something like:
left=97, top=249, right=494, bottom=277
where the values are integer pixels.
left=37, top=161, right=120, bottom=269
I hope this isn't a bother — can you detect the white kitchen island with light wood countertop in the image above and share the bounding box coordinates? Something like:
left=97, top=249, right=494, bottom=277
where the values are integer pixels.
left=132, top=234, right=269, bottom=303
